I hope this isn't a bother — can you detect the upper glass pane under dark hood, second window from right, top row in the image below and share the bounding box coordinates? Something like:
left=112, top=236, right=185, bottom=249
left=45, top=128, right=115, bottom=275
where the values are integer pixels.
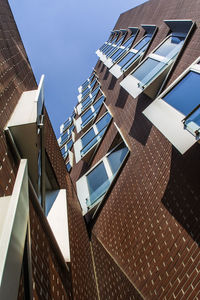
left=154, top=36, right=185, bottom=57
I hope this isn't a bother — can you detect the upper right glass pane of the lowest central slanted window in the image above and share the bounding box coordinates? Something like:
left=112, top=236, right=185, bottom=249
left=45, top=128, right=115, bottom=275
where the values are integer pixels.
left=107, top=143, right=128, bottom=175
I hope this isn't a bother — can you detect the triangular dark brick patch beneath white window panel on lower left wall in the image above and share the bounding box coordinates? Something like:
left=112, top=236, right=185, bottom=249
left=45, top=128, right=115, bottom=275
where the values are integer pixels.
left=30, top=199, right=71, bottom=300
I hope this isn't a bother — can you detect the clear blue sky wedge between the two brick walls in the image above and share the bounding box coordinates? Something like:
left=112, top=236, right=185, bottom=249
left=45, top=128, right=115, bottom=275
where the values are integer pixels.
left=9, top=0, right=145, bottom=137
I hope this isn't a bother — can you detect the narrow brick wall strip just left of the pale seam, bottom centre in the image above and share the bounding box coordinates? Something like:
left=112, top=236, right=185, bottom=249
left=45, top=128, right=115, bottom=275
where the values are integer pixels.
left=67, top=177, right=98, bottom=300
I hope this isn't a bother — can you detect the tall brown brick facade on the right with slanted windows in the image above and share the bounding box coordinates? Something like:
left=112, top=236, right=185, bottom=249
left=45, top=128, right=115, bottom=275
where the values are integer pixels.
left=58, top=0, right=200, bottom=300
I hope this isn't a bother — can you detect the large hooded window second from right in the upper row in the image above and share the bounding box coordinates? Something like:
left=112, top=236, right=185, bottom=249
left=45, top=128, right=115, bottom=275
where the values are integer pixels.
left=120, top=20, right=193, bottom=98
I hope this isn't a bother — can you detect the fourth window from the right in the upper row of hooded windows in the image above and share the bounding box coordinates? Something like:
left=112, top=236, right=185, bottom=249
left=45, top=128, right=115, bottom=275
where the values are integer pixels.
left=104, top=27, right=139, bottom=68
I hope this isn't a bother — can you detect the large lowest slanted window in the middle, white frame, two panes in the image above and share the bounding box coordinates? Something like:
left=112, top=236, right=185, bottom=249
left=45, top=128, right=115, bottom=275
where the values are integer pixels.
left=76, top=141, right=129, bottom=221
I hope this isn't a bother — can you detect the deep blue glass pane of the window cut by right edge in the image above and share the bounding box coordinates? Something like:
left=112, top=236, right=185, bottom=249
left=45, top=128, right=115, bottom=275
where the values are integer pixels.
left=163, top=71, right=200, bottom=116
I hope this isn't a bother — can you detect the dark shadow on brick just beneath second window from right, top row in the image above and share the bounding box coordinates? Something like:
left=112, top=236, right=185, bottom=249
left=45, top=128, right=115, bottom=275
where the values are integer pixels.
left=129, top=94, right=152, bottom=145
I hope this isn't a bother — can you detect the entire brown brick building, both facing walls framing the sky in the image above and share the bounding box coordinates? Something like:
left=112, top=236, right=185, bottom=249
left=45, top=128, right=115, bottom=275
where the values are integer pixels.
left=0, top=0, right=200, bottom=299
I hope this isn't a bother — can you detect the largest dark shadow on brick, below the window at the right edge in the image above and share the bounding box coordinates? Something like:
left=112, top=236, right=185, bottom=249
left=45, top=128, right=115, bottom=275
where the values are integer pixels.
left=162, top=143, right=200, bottom=246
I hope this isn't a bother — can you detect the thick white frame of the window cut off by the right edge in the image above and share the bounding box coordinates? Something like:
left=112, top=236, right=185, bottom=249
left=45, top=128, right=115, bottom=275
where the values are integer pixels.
left=143, top=56, right=200, bottom=154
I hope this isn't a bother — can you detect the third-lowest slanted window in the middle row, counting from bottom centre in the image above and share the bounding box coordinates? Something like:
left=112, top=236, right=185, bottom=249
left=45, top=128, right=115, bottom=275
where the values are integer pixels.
left=76, top=95, right=105, bottom=132
